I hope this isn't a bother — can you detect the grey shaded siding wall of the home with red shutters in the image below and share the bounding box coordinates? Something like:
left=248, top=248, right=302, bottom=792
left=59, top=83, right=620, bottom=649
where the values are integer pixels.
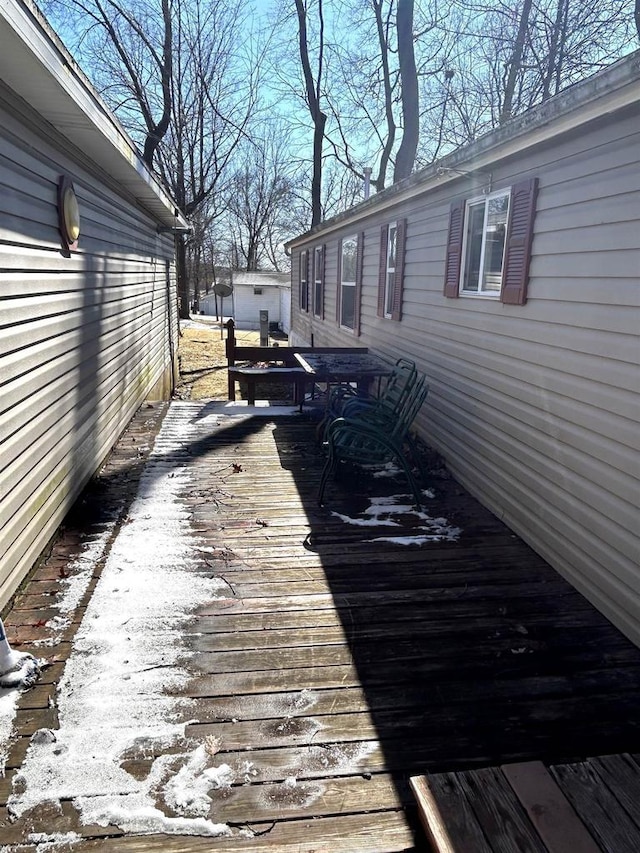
left=293, top=75, right=640, bottom=643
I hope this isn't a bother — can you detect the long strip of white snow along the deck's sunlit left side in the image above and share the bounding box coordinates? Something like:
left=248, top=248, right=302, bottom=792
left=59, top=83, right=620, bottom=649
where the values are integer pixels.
left=3, top=411, right=234, bottom=836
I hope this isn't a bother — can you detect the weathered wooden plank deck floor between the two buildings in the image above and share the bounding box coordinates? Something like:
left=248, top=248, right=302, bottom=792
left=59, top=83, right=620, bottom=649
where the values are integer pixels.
left=0, top=403, right=640, bottom=853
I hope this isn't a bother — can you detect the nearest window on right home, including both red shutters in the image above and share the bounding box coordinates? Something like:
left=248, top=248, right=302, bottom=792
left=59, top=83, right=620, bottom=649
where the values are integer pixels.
left=444, top=178, right=538, bottom=305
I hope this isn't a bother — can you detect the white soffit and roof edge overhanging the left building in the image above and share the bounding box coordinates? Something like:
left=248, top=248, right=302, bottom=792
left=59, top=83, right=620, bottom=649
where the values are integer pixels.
left=0, top=0, right=186, bottom=225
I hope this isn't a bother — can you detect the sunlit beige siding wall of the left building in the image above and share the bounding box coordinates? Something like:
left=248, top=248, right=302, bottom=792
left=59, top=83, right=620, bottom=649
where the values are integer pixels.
left=0, top=89, right=177, bottom=608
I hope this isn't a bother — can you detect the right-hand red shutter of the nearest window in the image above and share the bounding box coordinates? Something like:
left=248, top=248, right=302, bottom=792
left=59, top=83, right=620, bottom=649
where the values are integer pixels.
left=500, top=178, right=538, bottom=305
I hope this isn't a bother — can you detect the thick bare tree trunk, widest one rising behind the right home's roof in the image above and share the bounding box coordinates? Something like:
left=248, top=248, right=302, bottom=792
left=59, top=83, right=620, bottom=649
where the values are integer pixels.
left=393, top=0, right=420, bottom=183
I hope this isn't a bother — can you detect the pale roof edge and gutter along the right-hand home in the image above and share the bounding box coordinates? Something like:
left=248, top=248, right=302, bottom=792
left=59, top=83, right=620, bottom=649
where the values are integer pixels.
left=285, top=50, right=640, bottom=251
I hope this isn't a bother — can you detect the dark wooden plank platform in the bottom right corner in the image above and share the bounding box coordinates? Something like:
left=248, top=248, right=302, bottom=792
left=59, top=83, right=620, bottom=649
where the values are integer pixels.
left=410, top=755, right=640, bottom=853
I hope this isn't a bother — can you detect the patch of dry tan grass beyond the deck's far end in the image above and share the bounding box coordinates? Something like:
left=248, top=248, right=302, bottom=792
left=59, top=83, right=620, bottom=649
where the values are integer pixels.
left=174, top=321, right=284, bottom=400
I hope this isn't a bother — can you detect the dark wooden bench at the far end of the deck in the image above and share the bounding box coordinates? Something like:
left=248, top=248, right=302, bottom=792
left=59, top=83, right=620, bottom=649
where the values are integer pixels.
left=225, top=320, right=368, bottom=405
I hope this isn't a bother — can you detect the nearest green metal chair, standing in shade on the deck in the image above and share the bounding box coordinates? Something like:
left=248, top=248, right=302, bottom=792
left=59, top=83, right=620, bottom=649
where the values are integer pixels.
left=318, top=376, right=429, bottom=509
